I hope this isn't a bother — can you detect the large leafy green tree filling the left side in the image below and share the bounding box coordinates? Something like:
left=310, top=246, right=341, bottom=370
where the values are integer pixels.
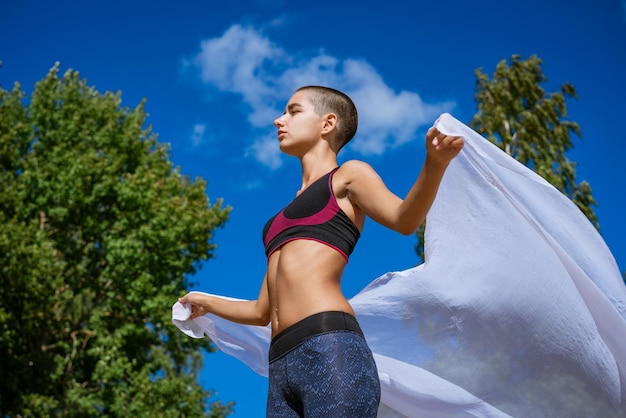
left=0, top=64, right=231, bottom=417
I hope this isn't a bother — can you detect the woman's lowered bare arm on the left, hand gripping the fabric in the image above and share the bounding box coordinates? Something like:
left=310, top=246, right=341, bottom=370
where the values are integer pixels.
left=178, top=274, right=270, bottom=325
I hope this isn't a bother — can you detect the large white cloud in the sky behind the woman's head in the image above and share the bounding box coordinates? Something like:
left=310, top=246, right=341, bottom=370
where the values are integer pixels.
left=188, top=25, right=454, bottom=169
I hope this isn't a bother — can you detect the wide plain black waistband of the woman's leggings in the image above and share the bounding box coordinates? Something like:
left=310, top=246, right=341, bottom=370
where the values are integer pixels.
left=269, top=311, right=363, bottom=362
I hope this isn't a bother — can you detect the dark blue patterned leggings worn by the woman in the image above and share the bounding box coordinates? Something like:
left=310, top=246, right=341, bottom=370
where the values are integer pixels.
left=267, top=312, right=380, bottom=418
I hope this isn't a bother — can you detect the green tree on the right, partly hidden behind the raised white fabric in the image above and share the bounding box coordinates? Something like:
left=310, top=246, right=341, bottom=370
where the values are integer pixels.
left=416, top=55, right=599, bottom=260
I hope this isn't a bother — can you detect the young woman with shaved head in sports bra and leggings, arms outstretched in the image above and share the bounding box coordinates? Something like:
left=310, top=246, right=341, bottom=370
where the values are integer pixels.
left=179, top=86, right=463, bottom=418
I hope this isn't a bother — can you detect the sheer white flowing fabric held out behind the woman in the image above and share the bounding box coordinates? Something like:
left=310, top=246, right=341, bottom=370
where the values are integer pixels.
left=173, top=114, right=626, bottom=418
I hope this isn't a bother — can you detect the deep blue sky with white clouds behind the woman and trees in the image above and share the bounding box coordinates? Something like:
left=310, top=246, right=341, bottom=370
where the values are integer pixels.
left=0, top=0, right=626, bottom=417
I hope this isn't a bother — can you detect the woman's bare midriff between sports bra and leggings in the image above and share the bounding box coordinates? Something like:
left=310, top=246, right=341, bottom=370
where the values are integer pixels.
left=267, top=239, right=354, bottom=335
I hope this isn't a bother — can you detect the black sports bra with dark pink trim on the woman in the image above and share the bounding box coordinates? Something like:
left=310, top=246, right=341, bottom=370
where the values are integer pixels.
left=263, top=167, right=361, bottom=260
